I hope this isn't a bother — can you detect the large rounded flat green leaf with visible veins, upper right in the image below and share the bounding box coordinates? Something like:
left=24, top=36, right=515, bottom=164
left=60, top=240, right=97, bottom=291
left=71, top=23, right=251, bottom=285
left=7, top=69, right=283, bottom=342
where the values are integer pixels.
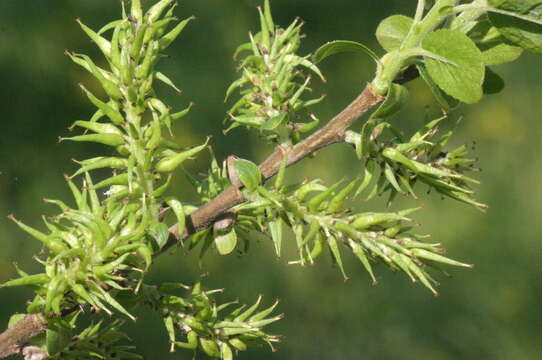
left=423, top=29, right=485, bottom=104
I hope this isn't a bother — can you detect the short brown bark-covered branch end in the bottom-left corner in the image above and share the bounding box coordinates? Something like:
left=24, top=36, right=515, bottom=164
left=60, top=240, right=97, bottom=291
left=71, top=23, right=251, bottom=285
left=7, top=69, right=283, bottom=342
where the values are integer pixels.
left=0, top=314, right=47, bottom=359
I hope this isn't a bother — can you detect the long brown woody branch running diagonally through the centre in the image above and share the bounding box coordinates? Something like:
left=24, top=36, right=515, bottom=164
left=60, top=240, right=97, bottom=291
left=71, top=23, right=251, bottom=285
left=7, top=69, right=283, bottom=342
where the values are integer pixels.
left=162, top=85, right=384, bottom=255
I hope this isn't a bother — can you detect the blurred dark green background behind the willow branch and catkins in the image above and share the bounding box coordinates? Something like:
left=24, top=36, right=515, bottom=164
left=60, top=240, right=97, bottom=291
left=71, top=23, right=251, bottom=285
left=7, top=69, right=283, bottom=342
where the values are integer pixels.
left=0, top=0, right=542, bottom=360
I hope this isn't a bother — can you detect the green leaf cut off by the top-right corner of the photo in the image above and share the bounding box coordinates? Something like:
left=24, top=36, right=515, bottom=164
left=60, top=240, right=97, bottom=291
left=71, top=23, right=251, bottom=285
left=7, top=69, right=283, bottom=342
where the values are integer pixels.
left=489, top=0, right=542, bottom=54
